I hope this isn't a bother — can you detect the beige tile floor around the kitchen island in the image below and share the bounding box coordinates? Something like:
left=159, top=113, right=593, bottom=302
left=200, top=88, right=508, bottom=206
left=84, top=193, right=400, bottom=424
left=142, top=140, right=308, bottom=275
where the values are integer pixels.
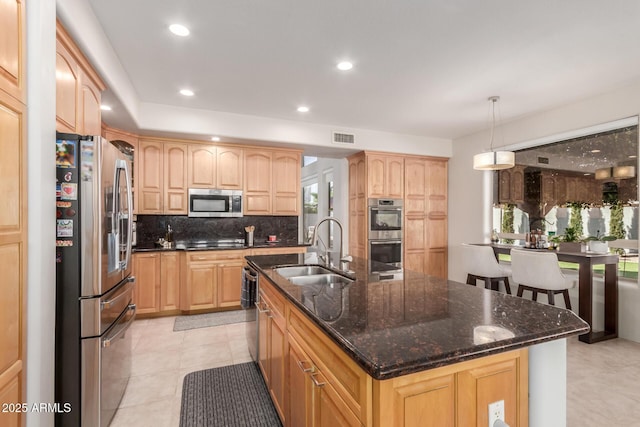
left=111, top=317, right=640, bottom=427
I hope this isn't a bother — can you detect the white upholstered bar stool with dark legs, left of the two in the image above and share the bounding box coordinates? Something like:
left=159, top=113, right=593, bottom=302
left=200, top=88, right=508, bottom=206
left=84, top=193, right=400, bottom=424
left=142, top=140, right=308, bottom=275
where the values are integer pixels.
left=462, top=243, right=511, bottom=294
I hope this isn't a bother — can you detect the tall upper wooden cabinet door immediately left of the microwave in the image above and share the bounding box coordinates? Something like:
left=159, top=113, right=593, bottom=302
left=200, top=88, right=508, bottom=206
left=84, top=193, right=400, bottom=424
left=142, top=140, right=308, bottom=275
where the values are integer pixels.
left=163, top=144, right=188, bottom=215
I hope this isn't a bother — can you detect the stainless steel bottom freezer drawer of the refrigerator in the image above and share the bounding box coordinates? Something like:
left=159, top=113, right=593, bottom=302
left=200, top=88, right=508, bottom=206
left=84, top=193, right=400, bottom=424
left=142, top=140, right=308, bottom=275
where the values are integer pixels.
left=80, top=304, right=136, bottom=427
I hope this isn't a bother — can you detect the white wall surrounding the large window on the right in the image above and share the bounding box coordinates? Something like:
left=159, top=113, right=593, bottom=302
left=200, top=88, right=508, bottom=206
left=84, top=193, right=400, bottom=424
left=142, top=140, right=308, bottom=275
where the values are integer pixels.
left=449, top=84, right=640, bottom=342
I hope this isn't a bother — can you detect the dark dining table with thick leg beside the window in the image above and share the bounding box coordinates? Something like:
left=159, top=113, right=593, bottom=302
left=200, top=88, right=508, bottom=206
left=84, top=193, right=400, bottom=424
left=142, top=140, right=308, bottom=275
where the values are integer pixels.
left=480, top=243, right=619, bottom=344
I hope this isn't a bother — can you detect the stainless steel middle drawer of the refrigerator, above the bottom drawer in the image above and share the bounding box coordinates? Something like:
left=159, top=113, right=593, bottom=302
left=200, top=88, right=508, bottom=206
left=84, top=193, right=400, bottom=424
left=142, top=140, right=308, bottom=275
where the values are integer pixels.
left=80, top=276, right=135, bottom=338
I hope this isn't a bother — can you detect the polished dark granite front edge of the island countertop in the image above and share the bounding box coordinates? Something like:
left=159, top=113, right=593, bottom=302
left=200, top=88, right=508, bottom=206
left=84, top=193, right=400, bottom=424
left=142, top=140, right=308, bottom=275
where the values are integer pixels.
left=248, top=257, right=589, bottom=380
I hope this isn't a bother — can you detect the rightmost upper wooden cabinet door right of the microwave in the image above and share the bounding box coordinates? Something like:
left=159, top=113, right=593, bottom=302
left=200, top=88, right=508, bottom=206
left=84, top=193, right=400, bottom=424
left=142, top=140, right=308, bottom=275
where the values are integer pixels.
left=272, top=151, right=302, bottom=216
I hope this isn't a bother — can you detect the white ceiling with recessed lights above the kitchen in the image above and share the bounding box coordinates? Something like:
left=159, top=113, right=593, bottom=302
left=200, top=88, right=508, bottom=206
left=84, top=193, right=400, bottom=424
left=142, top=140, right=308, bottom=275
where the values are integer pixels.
left=82, top=0, right=640, bottom=145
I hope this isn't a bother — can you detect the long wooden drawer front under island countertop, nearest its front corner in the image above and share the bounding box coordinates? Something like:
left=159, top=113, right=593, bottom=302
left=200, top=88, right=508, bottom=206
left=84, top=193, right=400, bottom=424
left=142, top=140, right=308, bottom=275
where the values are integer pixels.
left=287, top=308, right=372, bottom=425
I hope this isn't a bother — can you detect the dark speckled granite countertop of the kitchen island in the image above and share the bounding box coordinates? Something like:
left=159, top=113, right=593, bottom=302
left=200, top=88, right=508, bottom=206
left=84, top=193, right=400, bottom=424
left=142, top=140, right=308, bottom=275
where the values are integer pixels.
left=246, top=254, right=589, bottom=380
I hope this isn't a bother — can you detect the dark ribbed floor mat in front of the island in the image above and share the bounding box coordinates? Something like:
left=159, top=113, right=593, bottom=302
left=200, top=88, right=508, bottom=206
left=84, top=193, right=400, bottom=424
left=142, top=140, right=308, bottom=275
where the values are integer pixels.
left=180, top=362, right=282, bottom=427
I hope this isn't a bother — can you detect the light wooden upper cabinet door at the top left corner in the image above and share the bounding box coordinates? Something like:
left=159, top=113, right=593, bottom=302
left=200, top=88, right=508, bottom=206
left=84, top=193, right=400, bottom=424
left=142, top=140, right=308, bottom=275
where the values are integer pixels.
left=0, top=0, right=27, bottom=102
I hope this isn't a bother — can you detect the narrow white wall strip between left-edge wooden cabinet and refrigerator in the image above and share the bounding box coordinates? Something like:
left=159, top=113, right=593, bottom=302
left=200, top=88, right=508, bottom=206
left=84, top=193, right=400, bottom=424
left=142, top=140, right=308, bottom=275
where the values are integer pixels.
left=26, top=0, right=57, bottom=427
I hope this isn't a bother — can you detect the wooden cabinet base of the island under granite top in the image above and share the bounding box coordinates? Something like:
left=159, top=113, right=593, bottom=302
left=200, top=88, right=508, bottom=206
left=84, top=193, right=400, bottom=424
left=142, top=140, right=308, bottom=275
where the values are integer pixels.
left=259, top=278, right=529, bottom=427
